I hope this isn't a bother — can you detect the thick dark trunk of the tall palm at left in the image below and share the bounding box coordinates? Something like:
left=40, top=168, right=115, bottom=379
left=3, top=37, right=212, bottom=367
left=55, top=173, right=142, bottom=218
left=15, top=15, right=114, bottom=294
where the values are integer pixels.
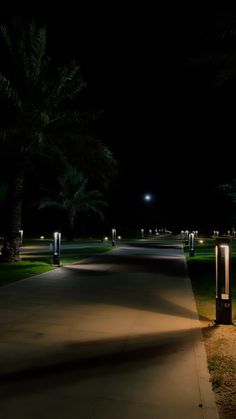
left=1, top=169, right=24, bottom=262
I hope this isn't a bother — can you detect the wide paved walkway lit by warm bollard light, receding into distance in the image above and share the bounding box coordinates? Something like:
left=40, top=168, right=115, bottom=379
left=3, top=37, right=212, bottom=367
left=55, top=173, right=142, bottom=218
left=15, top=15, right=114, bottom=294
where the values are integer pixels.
left=0, top=240, right=218, bottom=419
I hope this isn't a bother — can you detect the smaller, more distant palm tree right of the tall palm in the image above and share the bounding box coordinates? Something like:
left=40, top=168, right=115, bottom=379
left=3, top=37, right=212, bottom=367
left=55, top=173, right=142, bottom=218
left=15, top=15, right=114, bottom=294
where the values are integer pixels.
left=39, top=166, right=107, bottom=238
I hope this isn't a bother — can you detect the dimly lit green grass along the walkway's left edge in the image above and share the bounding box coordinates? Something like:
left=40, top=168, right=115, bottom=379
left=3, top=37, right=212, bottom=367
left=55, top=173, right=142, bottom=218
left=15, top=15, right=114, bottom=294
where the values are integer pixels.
left=0, top=245, right=112, bottom=286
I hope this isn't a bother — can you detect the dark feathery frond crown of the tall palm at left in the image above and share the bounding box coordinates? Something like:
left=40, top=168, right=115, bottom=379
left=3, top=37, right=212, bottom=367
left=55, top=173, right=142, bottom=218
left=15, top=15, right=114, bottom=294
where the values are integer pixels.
left=0, top=19, right=85, bottom=163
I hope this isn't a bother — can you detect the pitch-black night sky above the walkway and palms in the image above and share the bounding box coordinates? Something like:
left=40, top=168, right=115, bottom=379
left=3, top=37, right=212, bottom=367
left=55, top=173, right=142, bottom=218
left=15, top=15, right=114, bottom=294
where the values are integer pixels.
left=1, top=1, right=236, bottom=235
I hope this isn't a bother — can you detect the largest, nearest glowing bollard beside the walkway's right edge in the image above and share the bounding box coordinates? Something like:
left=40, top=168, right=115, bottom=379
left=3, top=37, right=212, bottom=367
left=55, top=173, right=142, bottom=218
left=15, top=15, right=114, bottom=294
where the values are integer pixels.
left=216, top=237, right=232, bottom=324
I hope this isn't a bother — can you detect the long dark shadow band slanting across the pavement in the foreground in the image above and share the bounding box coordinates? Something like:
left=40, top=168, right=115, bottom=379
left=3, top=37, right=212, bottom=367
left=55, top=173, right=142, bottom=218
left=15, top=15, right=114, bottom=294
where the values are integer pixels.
left=0, top=328, right=201, bottom=399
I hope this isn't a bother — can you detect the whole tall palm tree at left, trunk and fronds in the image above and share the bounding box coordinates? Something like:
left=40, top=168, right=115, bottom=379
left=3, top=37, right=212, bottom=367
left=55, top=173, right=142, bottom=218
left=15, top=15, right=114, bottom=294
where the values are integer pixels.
left=0, top=18, right=113, bottom=260
